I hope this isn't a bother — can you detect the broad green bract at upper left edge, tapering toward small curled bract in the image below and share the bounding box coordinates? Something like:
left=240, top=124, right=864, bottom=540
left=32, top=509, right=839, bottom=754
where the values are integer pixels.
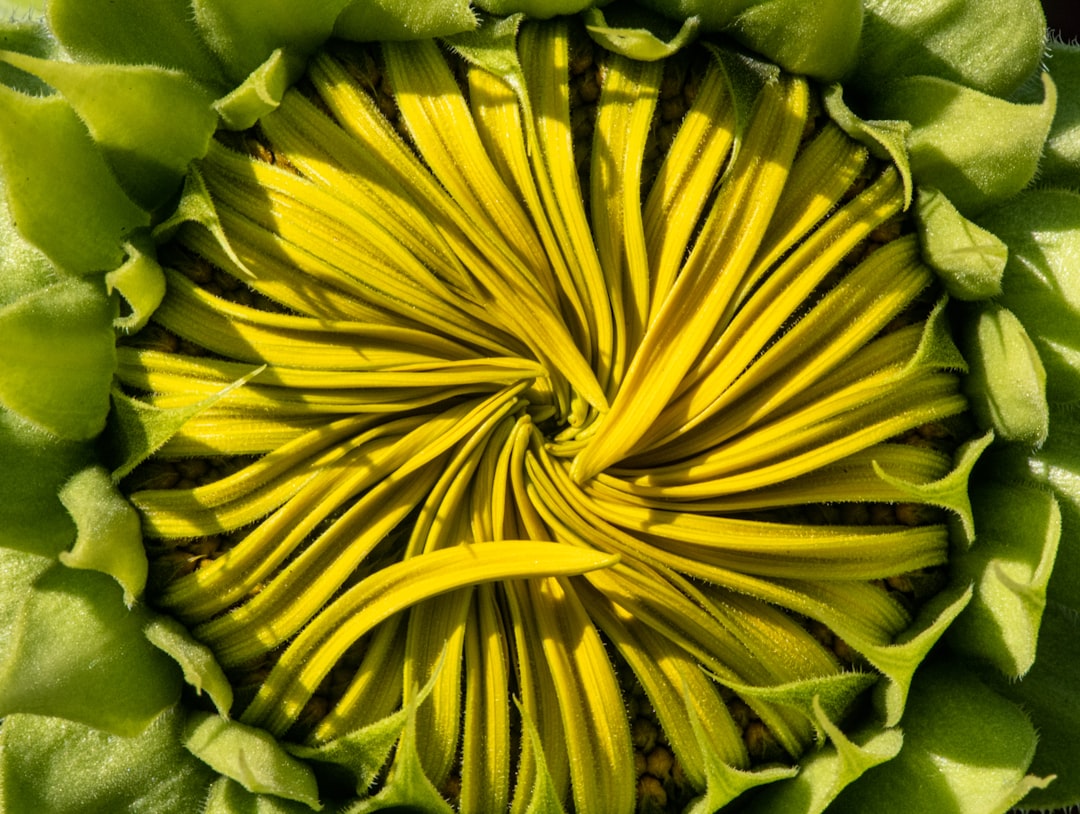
left=0, top=86, right=150, bottom=274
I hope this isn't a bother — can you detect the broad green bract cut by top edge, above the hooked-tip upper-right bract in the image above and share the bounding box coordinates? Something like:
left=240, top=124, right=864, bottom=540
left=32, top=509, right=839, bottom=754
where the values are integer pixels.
left=849, top=0, right=1047, bottom=96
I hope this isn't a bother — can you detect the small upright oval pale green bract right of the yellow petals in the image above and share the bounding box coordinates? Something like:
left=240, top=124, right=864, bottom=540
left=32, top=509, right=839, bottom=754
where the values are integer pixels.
left=960, top=303, right=1050, bottom=446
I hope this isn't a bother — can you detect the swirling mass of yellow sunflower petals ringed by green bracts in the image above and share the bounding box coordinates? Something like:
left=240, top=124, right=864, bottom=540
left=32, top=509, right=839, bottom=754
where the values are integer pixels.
left=120, top=23, right=967, bottom=811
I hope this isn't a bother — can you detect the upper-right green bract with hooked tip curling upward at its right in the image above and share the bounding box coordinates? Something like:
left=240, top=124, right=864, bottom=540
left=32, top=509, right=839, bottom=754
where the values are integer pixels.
left=869, top=74, right=1057, bottom=214
